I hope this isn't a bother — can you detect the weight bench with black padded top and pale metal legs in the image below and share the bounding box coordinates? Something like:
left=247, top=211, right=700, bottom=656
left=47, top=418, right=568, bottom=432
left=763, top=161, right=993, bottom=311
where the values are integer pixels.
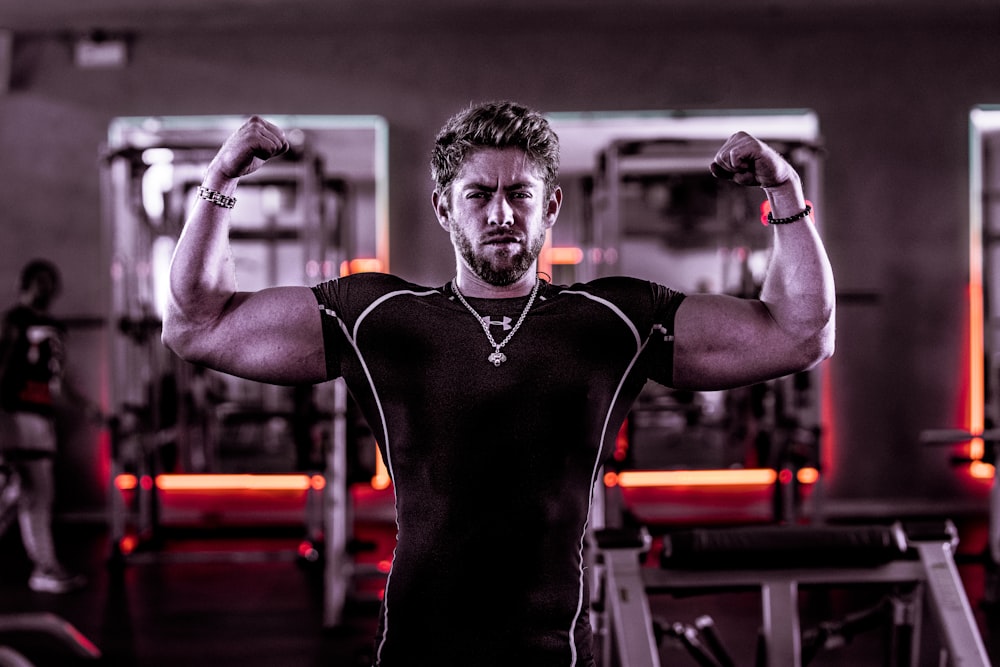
left=594, top=522, right=990, bottom=667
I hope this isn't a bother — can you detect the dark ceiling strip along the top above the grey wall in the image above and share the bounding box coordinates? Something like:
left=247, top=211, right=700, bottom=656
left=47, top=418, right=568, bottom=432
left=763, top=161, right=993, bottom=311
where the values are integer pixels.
left=0, top=0, right=1000, bottom=33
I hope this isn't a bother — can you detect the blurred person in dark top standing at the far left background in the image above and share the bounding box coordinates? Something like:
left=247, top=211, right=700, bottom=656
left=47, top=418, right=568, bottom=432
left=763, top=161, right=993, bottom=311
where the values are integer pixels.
left=0, top=259, right=84, bottom=593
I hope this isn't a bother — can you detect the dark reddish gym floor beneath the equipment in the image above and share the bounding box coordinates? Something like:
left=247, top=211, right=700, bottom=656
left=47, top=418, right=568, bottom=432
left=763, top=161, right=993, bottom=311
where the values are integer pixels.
left=0, top=521, right=1000, bottom=667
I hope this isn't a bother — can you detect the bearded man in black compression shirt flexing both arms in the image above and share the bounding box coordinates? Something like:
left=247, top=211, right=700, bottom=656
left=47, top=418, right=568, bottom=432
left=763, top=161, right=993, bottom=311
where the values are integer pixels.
left=163, top=102, right=834, bottom=667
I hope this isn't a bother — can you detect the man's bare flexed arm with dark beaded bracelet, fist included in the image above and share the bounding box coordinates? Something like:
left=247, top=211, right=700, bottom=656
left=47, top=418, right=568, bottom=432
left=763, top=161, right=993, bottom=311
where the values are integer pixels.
left=673, top=132, right=834, bottom=390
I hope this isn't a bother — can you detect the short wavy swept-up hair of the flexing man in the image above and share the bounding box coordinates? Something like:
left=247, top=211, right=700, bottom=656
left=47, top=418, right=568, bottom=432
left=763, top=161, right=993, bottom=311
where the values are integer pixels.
left=431, top=101, right=559, bottom=197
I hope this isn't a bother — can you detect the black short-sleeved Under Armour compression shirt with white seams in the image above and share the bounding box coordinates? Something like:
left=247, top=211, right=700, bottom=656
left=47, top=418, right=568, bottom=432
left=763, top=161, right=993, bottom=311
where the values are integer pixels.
left=314, top=274, right=683, bottom=667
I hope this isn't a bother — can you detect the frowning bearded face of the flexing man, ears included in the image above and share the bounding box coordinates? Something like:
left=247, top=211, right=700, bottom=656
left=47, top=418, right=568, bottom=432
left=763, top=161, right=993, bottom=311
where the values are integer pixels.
left=434, top=148, right=562, bottom=286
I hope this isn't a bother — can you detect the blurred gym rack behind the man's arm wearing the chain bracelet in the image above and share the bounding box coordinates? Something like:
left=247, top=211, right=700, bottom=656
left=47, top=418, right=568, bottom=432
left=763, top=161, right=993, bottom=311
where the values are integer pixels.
left=101, top=116, right=388, bottom=626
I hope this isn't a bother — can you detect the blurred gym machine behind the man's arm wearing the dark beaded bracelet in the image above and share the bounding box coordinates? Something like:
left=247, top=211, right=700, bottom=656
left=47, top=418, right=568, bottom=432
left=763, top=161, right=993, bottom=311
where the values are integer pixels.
left=564, top=121, right=822, bottom=523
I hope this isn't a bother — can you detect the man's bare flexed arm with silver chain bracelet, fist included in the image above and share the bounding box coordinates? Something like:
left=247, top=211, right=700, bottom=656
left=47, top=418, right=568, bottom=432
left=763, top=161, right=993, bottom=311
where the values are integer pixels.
left=162, top=116, right=326, bottom=384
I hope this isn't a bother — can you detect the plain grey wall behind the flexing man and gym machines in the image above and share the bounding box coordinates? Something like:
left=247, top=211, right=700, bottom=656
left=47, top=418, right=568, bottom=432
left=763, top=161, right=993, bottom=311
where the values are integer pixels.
left=0, top=10, right=1000, bottom=507
